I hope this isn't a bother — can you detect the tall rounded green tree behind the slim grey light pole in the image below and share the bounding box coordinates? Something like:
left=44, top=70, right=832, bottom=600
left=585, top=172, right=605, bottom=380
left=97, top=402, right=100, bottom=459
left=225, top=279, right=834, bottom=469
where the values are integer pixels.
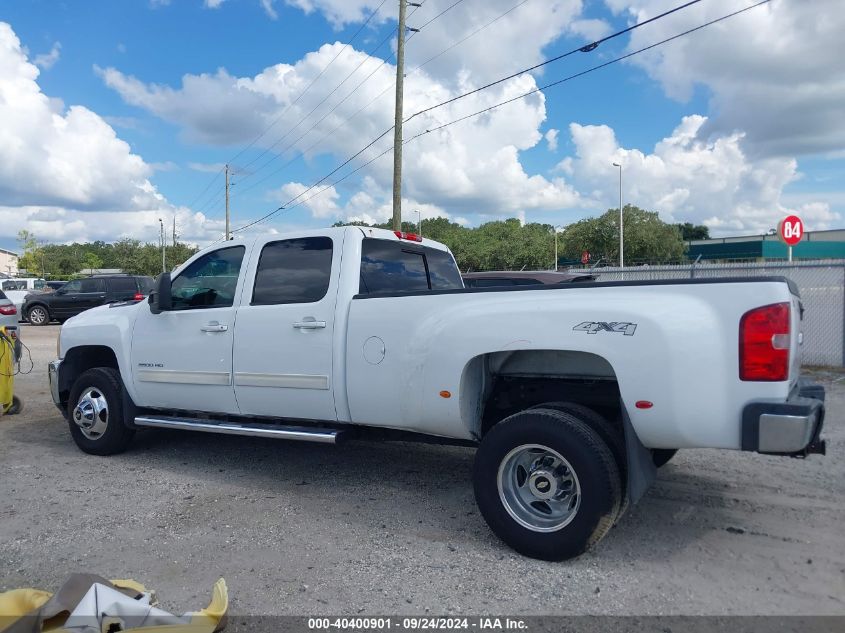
left=559, top=204, right=686, bottom=264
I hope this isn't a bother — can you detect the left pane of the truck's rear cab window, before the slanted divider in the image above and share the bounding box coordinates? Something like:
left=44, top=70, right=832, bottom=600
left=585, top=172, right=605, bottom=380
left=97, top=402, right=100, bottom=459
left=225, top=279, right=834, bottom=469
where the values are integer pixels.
left=359, top=239, right=428, bottom=294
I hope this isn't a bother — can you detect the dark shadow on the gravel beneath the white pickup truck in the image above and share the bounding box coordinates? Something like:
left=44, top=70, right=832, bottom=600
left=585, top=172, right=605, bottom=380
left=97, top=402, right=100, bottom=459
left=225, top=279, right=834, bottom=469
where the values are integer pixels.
left=131, top=424, right=736, bottom=562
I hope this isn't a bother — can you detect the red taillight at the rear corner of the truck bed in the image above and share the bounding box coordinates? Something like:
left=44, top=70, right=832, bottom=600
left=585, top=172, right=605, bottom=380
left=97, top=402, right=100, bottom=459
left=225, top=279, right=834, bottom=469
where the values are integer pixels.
left=739, top=303, right=789, bottom=382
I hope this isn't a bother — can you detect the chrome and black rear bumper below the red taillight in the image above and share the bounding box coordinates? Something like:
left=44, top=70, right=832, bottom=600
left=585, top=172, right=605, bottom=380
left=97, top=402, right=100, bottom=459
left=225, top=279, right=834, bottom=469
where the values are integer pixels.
left=742, top=379, right=825, bottom=457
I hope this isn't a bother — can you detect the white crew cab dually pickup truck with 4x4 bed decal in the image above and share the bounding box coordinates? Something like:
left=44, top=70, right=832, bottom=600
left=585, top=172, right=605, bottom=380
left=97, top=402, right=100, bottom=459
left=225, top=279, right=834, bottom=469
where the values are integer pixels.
left=49, top=227, right=824, bottom=560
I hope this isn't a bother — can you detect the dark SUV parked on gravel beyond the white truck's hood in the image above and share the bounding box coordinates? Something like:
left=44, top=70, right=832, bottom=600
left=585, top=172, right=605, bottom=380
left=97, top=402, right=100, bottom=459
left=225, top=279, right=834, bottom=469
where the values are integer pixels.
left=21, top=275, right=153, bottom=325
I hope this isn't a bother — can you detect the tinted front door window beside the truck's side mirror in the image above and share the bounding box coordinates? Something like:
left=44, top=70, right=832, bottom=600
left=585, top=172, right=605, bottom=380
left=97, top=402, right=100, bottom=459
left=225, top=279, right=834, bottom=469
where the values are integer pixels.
left=171, top=246, right=246, bottom=310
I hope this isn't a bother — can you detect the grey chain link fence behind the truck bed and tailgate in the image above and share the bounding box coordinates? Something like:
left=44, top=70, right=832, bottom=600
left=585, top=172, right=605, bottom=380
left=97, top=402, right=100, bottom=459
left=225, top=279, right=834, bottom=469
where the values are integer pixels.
left=569, top=259, right=845, bottom=367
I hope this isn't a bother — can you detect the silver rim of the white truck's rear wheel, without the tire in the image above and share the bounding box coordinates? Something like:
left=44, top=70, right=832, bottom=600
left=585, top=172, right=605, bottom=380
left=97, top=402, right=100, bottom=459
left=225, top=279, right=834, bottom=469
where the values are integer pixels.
left=497, top=444, right=581, bottom=532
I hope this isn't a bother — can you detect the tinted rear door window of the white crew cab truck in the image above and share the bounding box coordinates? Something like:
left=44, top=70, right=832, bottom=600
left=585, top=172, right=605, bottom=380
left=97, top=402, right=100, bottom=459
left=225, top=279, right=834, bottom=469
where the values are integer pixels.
left=252, top=237, right=332, bottom=305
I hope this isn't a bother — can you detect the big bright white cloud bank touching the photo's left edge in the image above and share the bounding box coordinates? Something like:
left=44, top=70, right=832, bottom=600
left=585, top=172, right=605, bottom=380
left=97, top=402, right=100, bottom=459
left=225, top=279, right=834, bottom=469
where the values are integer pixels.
left=0, top=22, right=223, bottom=241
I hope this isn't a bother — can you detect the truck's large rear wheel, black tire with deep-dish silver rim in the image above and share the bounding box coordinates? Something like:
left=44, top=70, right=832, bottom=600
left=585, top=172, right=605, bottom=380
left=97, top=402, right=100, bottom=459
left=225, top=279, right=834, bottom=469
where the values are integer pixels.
left=474, top=409, right=622, bottom=561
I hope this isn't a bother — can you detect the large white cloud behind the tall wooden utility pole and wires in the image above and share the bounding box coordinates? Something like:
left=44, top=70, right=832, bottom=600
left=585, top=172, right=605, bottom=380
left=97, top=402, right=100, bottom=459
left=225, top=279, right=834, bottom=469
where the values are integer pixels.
left=100, top=43, right=580, bottom=222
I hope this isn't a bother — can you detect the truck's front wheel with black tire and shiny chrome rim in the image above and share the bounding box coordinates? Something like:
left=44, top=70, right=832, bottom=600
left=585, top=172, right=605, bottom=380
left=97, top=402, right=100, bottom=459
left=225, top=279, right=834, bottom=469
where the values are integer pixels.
left=68, top=367, right=134, bottom=455
